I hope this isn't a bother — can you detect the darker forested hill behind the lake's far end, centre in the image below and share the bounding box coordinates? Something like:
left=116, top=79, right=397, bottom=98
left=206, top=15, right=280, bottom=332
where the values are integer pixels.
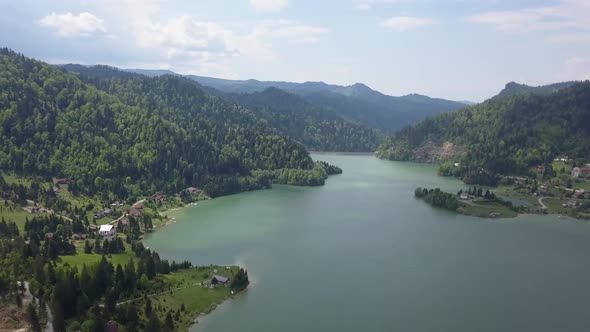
left=225, top=88, right=383, bottom=152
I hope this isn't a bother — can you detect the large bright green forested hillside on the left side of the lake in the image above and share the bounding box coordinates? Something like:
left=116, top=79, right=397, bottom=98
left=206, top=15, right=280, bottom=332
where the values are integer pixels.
left=0, top=49, right=336, bottom=197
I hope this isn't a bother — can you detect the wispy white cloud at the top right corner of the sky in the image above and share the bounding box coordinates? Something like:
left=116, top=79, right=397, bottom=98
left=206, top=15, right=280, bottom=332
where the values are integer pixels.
left=466, top=0, right=590, bottom=43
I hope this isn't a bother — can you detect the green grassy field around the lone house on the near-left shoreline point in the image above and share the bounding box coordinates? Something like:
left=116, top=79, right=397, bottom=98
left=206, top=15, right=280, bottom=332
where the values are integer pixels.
left=146, top=266, right=239, bottom=331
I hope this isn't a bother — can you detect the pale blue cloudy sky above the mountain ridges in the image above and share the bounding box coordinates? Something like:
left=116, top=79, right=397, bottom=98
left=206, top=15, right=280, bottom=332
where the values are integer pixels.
left=0, top=0, right=590, bottom=101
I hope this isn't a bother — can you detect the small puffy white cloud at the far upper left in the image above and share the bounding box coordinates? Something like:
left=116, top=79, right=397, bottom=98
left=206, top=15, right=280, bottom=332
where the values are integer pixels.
left=38, top=12, right=106, bottom=38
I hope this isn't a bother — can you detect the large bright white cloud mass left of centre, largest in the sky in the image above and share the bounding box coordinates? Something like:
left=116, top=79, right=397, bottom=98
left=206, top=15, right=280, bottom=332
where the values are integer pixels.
left=118, top=0, right=328, bottom=78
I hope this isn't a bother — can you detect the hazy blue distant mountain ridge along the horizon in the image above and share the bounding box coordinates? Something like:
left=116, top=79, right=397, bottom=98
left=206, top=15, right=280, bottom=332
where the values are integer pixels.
left=127, top=70, right=465, bottom=133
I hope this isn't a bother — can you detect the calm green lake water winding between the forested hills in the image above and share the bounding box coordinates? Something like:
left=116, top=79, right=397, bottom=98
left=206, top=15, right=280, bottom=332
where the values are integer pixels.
left=147, top=156, right=590, bottom=332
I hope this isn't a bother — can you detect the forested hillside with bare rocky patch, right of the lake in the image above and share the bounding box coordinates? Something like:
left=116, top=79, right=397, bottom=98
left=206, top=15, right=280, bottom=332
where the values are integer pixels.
left=378, top=81, right=590, bottom=183
